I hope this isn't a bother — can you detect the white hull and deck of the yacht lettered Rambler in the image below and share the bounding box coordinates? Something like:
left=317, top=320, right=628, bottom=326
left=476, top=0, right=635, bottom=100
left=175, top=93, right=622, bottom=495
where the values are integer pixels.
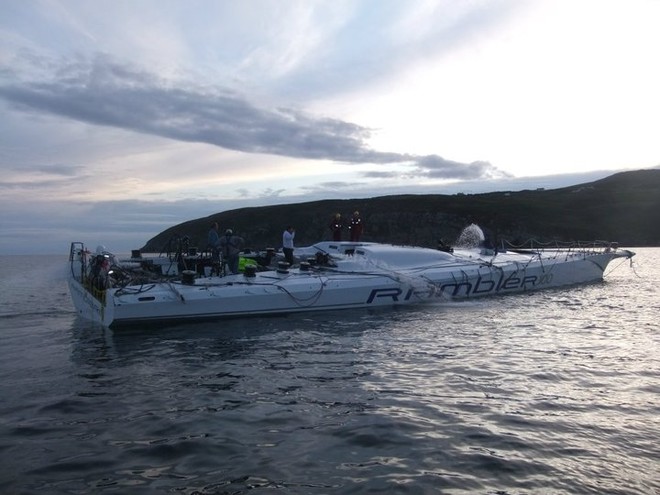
left=69, top=243, right=633, bottom=327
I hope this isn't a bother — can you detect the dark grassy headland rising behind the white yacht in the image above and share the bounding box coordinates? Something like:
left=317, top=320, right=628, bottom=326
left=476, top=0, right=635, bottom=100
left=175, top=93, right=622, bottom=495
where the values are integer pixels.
left=141, top=169, right=660, bottom=252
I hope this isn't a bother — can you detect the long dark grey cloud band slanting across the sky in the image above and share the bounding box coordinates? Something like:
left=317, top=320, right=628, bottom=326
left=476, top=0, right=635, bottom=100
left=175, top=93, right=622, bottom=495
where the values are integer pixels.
left=0, top=57, right=506, bottom=179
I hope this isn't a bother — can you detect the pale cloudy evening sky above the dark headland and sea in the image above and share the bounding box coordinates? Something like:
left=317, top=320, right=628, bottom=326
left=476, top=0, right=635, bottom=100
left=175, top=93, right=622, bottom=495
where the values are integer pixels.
left=0, top=0, right=660, bottom=254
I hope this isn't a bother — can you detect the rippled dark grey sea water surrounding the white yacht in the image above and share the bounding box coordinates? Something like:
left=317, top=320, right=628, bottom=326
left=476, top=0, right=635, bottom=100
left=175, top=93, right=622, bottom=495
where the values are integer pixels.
left=0, top=249, right=660, bottom=495
